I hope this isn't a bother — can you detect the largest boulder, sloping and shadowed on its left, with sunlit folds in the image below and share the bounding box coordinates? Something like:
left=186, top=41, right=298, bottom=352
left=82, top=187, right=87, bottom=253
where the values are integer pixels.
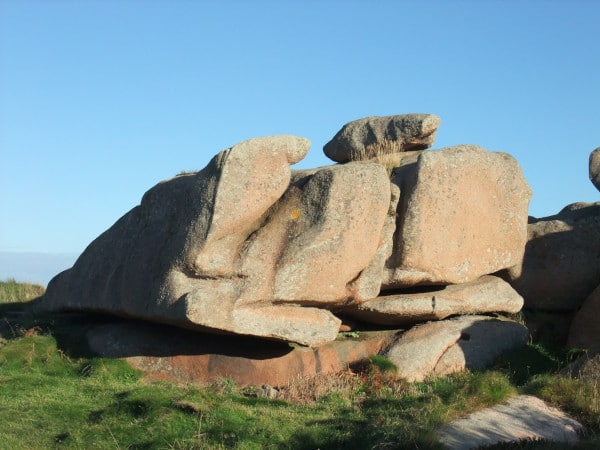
left=44, top=136, right=390, bottom=345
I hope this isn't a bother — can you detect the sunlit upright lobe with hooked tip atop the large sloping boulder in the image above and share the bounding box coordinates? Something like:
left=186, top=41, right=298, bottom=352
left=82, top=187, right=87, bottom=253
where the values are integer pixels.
left=195, top=136, right=310, bottom=277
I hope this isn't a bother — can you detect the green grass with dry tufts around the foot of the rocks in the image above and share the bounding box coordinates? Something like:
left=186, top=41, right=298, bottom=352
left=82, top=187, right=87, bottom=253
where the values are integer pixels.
left=0, top=280, right=600, bottom=450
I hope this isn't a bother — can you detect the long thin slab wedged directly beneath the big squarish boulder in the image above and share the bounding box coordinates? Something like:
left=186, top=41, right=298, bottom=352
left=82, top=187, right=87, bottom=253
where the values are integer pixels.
left=340, top=275, right=523, bottom=325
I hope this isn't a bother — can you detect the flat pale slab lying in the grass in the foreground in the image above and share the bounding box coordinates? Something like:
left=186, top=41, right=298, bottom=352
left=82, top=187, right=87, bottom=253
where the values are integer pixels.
left=438, top=395, right=583, bottom=450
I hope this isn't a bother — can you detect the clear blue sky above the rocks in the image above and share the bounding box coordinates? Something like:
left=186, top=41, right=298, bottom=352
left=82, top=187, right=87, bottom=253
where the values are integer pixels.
left=0, top=0, right=600, bottom=253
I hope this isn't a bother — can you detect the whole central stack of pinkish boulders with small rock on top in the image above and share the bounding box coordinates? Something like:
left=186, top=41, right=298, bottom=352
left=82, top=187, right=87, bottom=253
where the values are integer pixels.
left=42, top=114, right=531, bottom=380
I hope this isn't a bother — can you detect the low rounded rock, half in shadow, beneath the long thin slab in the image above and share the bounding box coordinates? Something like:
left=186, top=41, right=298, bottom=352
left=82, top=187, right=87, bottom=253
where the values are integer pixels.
left=385, top=316, right=529, bottom=382
